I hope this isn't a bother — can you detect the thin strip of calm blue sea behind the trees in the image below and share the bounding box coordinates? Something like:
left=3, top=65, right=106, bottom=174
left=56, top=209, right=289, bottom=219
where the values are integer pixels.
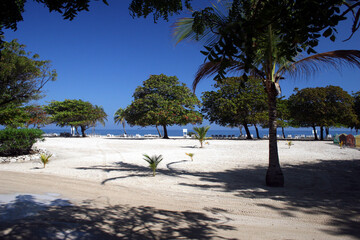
left=42, top=128, right=356, bottom=137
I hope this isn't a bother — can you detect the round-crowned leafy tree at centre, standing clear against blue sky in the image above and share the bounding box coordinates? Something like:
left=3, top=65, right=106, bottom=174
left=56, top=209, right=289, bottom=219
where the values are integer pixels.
left=125, top=74, right=202, bottom=138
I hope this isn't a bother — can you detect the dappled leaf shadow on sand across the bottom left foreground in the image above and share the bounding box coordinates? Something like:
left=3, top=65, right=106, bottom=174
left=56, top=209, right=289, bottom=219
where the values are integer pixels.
left=0, top=195, right=235, bottom=239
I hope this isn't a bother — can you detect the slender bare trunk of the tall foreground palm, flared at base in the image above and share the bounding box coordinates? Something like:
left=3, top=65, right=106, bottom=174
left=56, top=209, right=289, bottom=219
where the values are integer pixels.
left=266, top=86, right=284, bottom=187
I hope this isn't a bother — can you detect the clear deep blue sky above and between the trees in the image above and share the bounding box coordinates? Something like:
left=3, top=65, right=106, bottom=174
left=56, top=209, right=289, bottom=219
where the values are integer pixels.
left=5, top=0, right=360, bottom=129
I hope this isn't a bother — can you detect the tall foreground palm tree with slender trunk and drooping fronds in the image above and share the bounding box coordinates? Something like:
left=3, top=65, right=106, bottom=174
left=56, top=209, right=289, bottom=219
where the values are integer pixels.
left=174, top=3, right=360, bottom=187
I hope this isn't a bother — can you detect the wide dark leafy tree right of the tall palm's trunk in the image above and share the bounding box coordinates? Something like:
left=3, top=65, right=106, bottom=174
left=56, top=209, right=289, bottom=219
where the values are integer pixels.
left=289, top=86, right=356, bottom=140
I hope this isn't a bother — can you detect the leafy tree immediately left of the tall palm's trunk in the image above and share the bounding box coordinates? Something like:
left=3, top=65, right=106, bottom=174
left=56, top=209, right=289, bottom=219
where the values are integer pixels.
left=201, top=77, right=266, bottom=139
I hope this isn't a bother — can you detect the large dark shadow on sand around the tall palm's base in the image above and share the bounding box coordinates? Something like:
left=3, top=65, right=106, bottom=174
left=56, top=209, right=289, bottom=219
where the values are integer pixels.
left=79, top=159, right=360, bottom=239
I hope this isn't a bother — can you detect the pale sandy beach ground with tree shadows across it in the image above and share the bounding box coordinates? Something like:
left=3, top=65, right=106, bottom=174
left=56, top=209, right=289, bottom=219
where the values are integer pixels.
left=0, top=137, right=360, bottom=239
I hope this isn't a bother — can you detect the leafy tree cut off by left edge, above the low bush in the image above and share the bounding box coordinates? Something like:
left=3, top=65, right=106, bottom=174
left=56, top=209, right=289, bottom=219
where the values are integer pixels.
left=0, top=40, right=56, bottom=109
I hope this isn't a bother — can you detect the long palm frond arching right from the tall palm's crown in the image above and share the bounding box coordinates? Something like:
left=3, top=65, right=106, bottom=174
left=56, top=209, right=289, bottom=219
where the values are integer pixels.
left=277, top=50, right=360, bottom=77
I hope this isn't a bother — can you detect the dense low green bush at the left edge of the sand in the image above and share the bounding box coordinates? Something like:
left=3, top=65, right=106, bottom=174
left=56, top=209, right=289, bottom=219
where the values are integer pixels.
left=0, top=128, right=44, bottom=156
